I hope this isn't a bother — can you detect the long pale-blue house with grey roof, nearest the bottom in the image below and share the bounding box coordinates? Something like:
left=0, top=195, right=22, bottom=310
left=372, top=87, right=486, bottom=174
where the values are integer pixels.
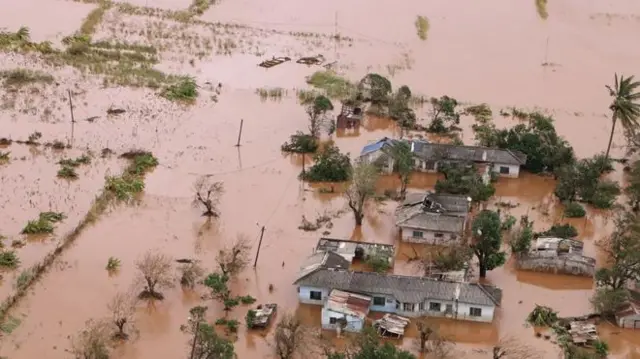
left=294, top=268, right=502, bottom=322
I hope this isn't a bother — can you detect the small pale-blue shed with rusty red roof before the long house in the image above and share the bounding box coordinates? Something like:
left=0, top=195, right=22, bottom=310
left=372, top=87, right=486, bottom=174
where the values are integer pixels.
left=322, top=289, right=371, bottom=332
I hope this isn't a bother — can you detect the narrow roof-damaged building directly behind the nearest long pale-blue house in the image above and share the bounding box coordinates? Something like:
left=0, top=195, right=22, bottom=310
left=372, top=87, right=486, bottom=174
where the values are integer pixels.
left=314, top=238, right=395, bottom=265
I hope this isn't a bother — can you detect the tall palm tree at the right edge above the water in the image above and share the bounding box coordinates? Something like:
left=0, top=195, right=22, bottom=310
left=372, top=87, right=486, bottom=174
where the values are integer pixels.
left=605, top=74, right=640, bottom=159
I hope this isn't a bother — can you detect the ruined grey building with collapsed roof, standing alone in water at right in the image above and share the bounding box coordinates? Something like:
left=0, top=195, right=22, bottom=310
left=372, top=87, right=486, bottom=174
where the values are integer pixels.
left=516, top=237, right=596, bottom=277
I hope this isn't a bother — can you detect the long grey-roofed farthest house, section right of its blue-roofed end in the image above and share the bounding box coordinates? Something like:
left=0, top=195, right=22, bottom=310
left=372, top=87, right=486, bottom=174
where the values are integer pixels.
left=414, top=143, right=527, bottom=178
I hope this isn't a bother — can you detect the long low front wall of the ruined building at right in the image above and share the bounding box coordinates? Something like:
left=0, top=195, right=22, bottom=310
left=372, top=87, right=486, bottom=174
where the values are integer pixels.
left=516, top=255, right=595, bottom=277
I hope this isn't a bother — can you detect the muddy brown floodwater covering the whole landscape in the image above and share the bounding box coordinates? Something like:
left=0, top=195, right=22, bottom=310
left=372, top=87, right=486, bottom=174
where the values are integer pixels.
left=0, top=0, right=640, bottom=359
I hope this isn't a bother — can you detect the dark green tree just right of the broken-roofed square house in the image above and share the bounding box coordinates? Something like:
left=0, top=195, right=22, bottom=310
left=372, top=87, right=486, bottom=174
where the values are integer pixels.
left=471, top=210, right=506, bottom=278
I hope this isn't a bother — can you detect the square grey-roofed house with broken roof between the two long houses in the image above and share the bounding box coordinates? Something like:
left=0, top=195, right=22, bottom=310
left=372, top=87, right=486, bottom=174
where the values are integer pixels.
left=395, top=192, right=471, bottom=245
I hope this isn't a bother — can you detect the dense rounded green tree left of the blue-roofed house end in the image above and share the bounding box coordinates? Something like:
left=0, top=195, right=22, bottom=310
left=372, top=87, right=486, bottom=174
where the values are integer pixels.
left=301, top=144, right=351, bottom=182
